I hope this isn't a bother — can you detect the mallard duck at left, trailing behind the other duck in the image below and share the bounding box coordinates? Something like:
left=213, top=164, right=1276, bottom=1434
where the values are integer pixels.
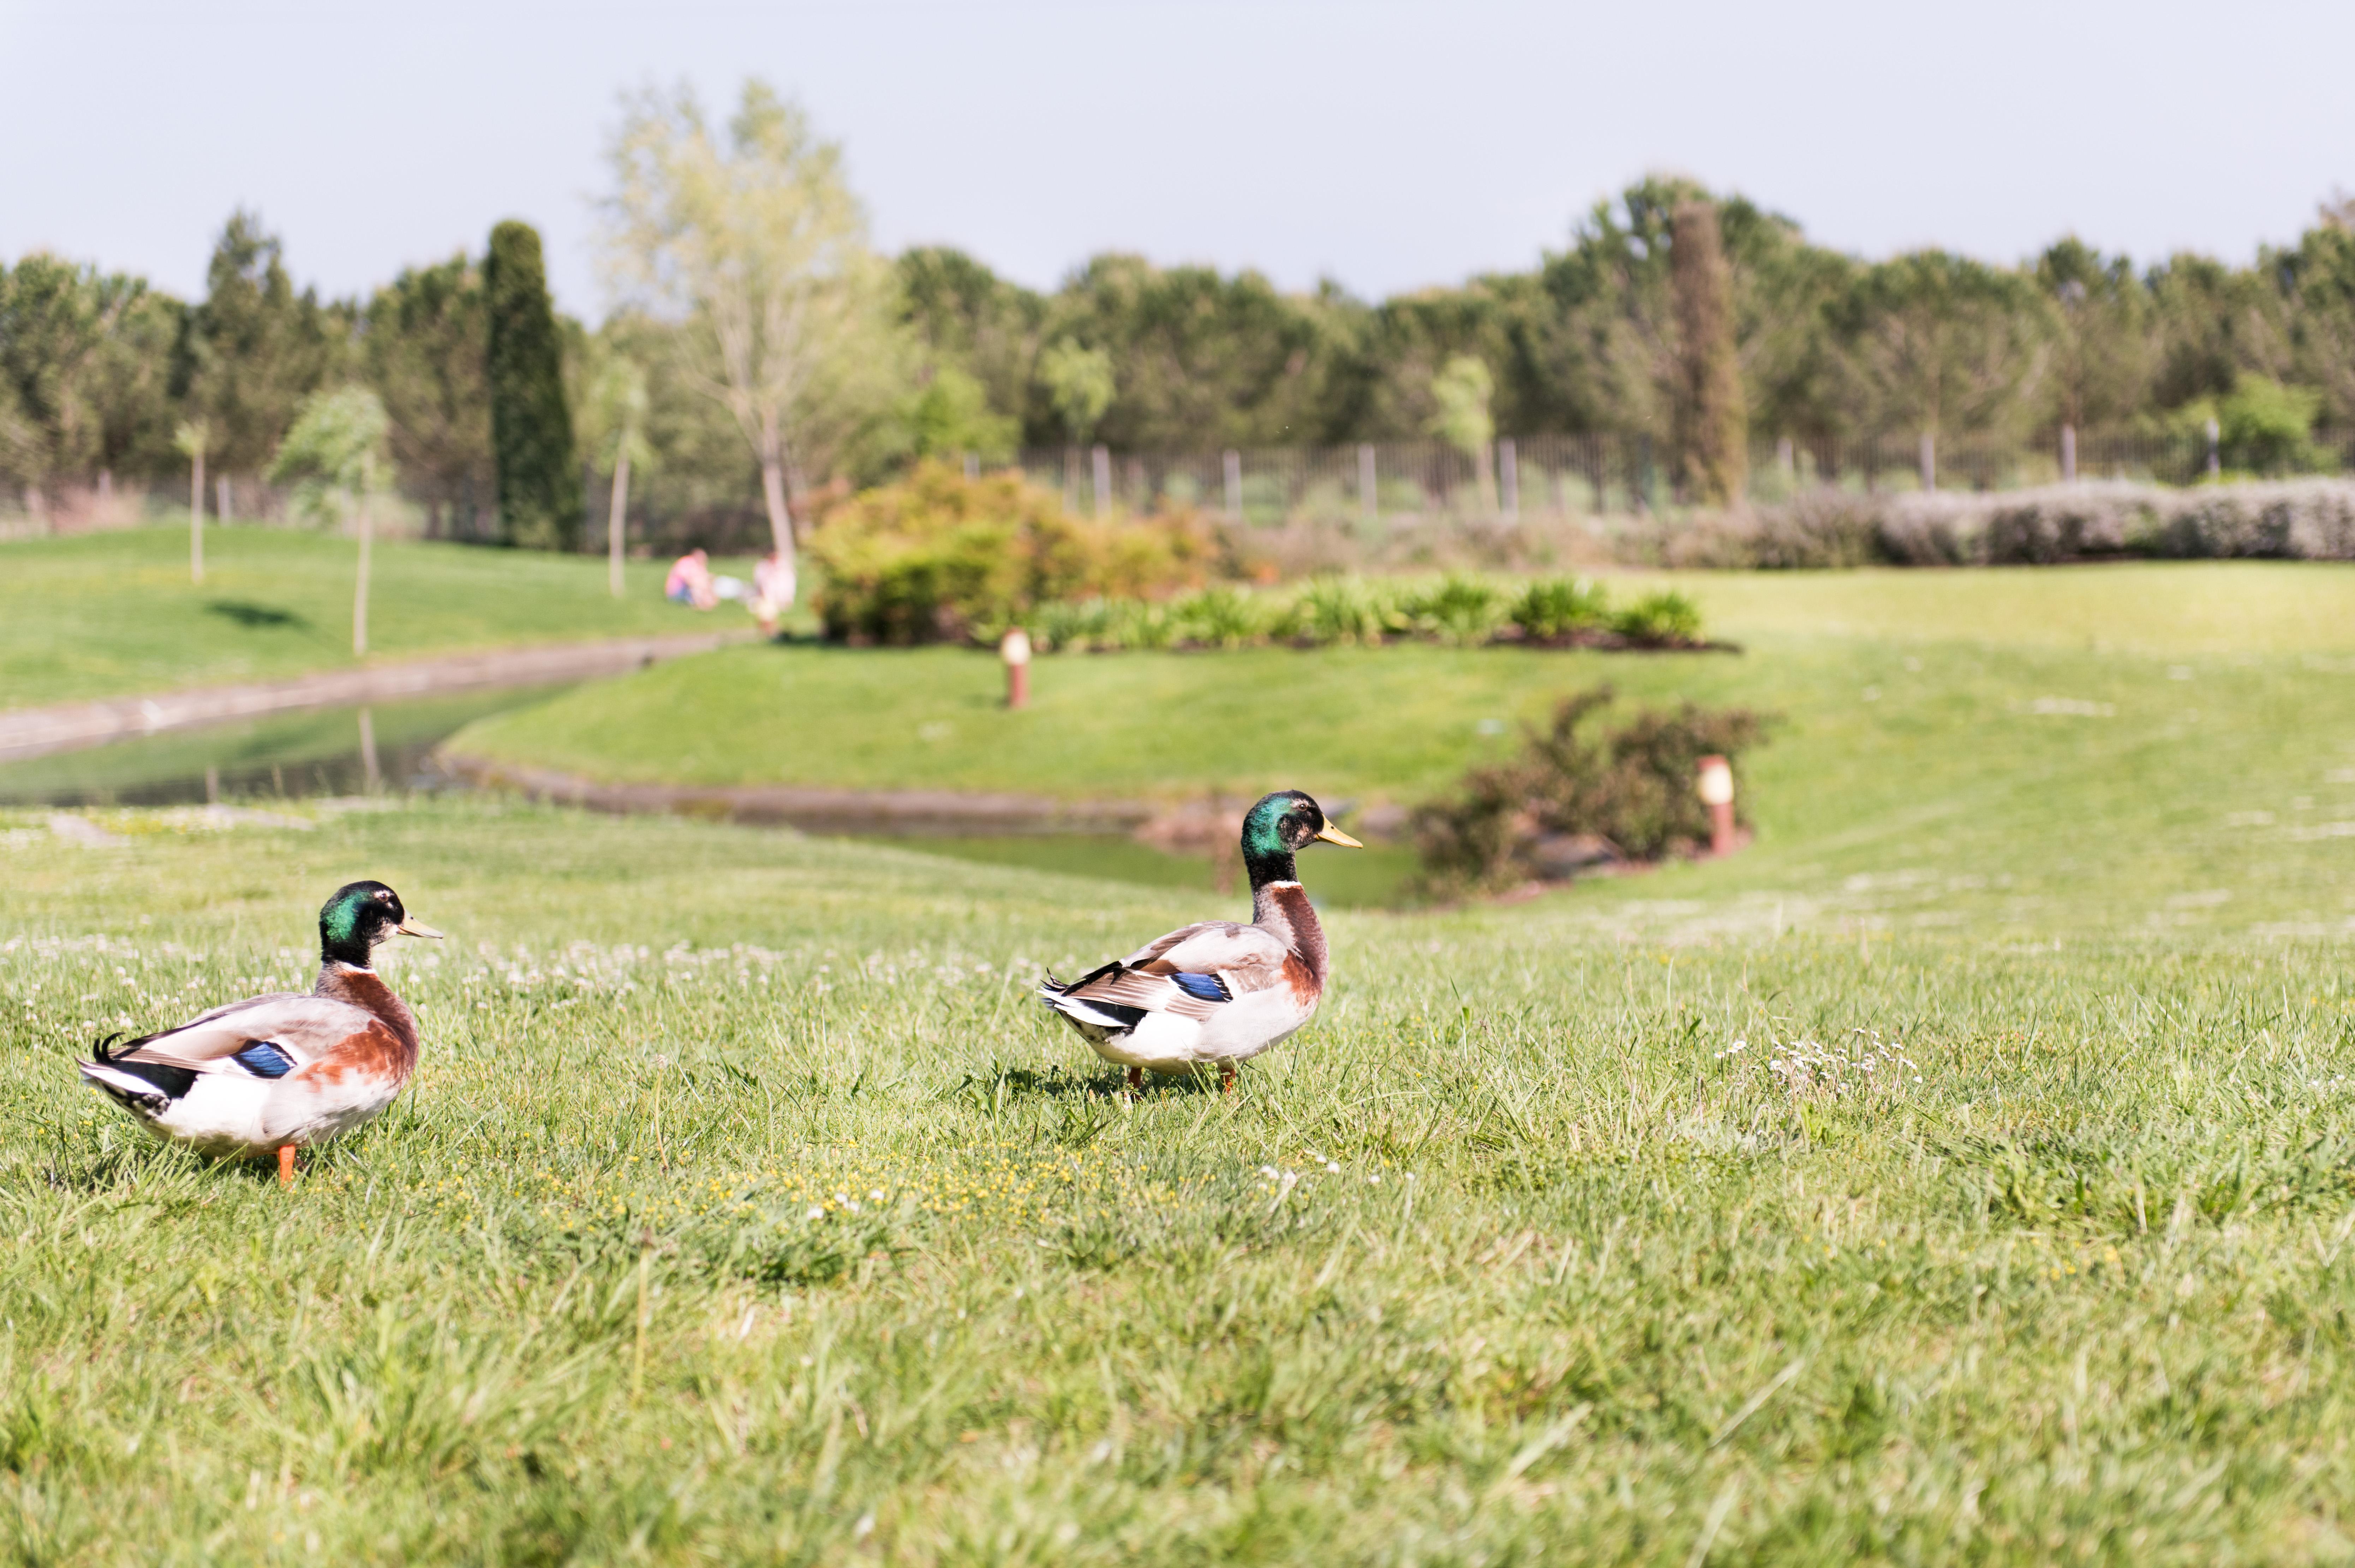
left=78, top=883, right=440, bottom=1184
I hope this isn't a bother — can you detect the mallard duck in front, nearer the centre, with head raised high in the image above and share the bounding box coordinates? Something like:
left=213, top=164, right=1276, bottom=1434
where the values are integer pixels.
left=1039, top=789, right=1366, bottom=1092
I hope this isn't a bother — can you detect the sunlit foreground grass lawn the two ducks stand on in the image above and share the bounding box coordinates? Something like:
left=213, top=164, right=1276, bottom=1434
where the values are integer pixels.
left=14, top=567, right=2355, bottom=1563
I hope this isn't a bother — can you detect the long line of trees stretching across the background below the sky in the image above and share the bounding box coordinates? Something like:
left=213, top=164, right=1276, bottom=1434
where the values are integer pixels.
left=0, top=82, right=2355, bottom=546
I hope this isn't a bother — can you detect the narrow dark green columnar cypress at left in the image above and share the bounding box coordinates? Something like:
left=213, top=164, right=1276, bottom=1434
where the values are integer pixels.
left=483, top=219, right=582, bottom=551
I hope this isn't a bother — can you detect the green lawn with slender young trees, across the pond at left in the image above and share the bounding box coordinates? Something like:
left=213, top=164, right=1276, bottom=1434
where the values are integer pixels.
left=0, top=527, right=787, bottom=709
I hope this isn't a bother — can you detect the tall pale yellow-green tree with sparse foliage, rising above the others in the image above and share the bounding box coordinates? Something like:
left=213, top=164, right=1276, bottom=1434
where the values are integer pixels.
left=605, top=80, right=904, bottom=586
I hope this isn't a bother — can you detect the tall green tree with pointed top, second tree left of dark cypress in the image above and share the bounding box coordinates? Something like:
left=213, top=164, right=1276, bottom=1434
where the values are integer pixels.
left=169, top=212, right=355, bottom=473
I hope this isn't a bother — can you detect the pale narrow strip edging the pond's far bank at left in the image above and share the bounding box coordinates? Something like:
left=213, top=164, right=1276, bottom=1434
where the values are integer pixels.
left=0, top=631, right=749, bottom=763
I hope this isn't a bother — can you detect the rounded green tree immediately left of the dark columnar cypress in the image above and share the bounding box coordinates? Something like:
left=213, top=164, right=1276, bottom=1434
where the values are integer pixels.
left=360, top=254, right=497, bottom=537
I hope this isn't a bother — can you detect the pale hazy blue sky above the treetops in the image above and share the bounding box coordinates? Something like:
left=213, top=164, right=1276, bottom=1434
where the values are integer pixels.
left=0, top=0, right=2355, bottom=320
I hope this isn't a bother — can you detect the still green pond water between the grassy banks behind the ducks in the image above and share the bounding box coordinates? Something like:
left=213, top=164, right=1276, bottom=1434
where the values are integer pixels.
left=0, top=687, right=1415, bottom=909
